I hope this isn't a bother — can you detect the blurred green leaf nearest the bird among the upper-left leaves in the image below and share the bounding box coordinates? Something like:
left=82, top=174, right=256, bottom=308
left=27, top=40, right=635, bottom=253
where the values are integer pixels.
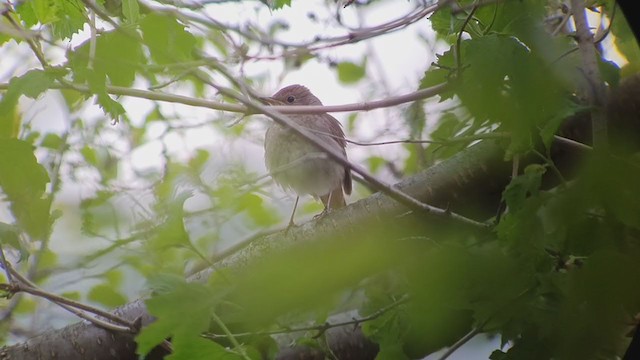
left=140, top=13, right=196, bottom=64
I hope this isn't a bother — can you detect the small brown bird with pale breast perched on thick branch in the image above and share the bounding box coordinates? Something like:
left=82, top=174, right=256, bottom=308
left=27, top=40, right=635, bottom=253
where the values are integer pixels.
left=261, top=85, right=351, bottom=226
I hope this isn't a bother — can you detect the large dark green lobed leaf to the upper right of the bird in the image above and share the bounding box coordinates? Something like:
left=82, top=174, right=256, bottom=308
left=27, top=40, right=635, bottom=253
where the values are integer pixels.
left=456, top=34, right=570, bottom=157
